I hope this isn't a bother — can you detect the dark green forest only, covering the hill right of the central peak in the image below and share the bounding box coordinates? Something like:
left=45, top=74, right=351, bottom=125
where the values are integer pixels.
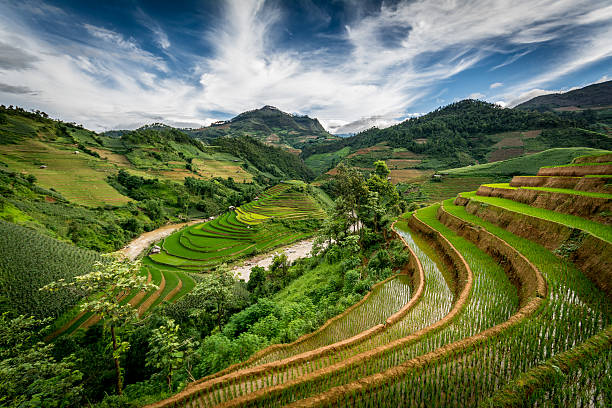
left=302, top=100, right=610, bottom=169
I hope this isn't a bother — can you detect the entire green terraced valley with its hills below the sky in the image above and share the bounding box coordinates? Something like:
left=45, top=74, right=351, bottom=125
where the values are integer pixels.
left=0, top=80, right=612, bottom=408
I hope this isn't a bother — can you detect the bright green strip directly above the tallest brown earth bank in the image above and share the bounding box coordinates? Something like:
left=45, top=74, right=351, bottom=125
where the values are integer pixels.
left=461, top=191, right=612, bottom=243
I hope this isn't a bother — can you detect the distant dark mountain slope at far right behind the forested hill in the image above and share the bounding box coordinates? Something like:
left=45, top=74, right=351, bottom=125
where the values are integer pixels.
left=516, top=81, right=612, bottom=111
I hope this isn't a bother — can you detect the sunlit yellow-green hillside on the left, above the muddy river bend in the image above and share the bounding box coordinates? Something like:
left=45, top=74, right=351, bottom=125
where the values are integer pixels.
left=0, top=107, right=312, bottom=252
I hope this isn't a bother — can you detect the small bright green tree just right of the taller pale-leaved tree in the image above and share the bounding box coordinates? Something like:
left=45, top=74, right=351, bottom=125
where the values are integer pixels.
left=146, top=319, right=195, bottom=392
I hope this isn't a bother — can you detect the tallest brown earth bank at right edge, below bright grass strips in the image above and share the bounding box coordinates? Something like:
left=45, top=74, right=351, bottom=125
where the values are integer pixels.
left=455, top=197, right=612, bottom=298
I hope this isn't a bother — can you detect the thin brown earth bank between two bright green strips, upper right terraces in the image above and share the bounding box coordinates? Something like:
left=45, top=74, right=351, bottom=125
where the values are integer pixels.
left=476, top=185, right=612, bottom=225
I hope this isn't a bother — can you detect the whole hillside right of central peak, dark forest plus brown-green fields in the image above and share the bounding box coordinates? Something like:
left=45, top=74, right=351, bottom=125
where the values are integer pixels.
left=302, top=100, right=612, bottom=177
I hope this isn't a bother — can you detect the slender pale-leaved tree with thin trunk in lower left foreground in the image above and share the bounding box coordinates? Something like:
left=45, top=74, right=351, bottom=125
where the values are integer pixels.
left=41, top=257, right=157, bottom=395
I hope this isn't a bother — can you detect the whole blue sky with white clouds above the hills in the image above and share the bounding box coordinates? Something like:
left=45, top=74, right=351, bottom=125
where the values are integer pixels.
left=0, top=0, right=612, bottom=133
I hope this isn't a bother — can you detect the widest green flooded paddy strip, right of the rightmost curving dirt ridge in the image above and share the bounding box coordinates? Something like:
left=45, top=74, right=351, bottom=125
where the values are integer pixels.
left=338, top=200, right=612, bottom=407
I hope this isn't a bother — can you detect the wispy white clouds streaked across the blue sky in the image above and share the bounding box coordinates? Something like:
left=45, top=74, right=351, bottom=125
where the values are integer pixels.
left=0, top=0, right=612, bottom=133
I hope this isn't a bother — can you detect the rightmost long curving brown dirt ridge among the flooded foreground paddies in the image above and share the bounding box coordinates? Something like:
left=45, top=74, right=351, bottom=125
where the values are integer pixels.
left=289, top=210, right=546, bottom=407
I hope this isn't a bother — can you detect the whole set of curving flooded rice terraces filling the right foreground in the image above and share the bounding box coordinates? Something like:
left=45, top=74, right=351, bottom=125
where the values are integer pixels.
left=148, top=151, right=612, bottom=407
